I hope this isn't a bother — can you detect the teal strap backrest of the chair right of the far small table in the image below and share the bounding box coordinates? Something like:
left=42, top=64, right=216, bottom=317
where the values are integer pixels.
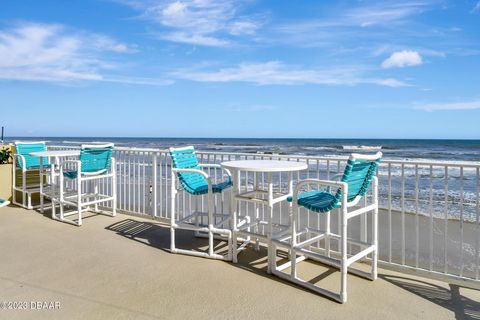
left=80, top=143, right=113, bottom=173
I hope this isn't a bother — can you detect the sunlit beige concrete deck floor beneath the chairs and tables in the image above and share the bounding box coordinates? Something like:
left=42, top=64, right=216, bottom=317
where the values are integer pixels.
left=0, top=207, right=480, bottom=320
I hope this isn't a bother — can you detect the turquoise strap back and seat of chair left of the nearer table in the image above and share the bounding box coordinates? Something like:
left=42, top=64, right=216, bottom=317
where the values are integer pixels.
left=170, top=148, right=232, bottom=195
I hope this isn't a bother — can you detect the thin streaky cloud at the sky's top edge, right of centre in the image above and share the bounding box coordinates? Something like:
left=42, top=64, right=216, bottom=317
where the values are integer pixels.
left=264, top=0, right=445, bottom=52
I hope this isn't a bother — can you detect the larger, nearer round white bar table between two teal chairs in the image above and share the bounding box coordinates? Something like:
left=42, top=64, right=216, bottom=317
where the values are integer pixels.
left=221, top=160, right=308, bottom=273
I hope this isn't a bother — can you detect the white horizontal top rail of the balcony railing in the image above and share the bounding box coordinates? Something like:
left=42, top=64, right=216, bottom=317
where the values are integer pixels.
left=49, top=145, right=480, bottom=168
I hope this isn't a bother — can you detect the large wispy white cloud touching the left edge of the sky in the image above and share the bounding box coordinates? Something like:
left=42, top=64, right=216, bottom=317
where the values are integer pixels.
left=0, top=23, right=171, bottom=84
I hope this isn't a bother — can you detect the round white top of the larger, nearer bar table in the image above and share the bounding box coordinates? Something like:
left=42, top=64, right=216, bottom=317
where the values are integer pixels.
left=221, top=160, right=308, bottom=172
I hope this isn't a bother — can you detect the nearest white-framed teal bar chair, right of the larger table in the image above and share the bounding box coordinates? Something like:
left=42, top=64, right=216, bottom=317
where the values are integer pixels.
left=273, top=152, right=382, bottom=303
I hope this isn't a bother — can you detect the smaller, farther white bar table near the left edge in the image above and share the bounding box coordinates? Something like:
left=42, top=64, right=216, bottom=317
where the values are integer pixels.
left=29, top=150, right=80, bottom=219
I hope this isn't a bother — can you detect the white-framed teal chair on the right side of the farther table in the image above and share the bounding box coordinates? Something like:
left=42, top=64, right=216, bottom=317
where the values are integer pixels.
left=58, top=143, right=117, bottom=226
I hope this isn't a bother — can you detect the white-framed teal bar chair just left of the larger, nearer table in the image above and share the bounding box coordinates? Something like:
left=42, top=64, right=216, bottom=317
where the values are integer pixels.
left=170, top=146, right=232, bottom=260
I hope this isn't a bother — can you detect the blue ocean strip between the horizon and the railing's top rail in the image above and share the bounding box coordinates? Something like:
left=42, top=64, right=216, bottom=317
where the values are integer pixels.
left=8, top=137, right=480, bottom=161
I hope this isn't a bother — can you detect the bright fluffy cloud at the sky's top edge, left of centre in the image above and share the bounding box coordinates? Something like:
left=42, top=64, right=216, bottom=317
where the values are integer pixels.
left=121, top=0, right=260, bottom=47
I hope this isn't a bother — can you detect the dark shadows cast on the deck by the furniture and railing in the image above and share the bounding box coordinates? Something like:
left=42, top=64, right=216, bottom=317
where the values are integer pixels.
left=106, top=219, right=480, bottom=320
